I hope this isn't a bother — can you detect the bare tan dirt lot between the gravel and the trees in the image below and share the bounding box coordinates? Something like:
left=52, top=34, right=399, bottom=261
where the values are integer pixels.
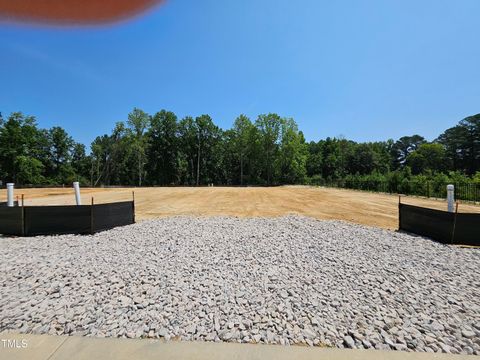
left=0, top=186, right=480, bottom=229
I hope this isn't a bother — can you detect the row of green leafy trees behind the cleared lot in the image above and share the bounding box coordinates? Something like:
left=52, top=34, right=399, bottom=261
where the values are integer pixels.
left=0, top=108, right=480, bottom=186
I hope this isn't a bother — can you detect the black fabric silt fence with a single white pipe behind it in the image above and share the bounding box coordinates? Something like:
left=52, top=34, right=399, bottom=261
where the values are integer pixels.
left=399, top=204, right=480, bottom=246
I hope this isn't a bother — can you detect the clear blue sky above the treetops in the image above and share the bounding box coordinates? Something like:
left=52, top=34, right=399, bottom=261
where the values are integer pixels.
left=0, top=0, right=480, bottom=144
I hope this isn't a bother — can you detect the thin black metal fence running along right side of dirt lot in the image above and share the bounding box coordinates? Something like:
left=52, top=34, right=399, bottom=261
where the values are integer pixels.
left=312, top=180, right=480, bottom=202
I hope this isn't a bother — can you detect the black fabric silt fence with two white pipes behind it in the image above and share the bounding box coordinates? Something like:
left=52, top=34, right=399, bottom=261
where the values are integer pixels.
left=0, top=201, right=135, bottom=236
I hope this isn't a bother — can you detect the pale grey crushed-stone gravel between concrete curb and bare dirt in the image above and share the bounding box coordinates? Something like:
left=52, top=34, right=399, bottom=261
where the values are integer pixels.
left=0, top=216, right=480, bottom=355
